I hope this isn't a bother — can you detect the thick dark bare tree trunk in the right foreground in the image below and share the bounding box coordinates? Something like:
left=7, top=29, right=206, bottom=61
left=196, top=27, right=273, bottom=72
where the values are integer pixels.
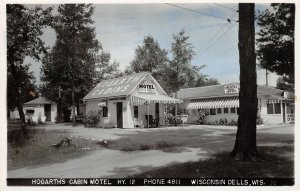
left=231, top=3, right=260, bottom=161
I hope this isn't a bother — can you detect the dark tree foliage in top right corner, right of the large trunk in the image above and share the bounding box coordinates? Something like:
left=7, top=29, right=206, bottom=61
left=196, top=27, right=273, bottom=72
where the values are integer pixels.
left=257, top=3, right=295, bottom=91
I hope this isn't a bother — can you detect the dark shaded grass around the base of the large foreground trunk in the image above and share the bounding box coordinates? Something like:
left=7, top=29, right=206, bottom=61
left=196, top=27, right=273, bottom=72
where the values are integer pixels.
left=131, top=146, right=294, bottom=178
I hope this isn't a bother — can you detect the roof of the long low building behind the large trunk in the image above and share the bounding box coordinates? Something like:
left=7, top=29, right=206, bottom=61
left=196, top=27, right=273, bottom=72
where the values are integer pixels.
left=177, top=83, right=283, bottom=99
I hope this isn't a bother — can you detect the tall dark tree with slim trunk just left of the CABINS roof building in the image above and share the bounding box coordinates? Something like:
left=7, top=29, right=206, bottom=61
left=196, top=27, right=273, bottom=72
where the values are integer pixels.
left=42, top=4, right=102, bottom=126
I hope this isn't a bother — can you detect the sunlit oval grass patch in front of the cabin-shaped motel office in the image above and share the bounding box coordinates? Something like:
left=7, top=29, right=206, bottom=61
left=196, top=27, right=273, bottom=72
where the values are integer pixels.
left=102, top=129, right=234, bottom=152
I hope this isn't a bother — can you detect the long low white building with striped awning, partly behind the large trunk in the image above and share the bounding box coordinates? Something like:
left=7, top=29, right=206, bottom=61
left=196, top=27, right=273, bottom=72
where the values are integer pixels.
left=177, top=83, right=294, bottom=123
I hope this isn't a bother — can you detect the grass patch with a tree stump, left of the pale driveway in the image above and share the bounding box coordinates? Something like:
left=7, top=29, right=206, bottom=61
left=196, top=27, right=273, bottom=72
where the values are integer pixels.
left=7, top=129, right=97, bottom=170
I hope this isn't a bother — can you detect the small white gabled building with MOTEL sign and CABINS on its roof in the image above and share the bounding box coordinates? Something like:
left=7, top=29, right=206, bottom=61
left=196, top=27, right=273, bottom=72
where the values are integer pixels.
left=83, top=72, right=182, bottom=128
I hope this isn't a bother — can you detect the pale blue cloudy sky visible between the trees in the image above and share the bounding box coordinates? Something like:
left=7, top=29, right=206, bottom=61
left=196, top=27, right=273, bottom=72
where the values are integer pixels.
left=25, top=3, right=278, bottom=86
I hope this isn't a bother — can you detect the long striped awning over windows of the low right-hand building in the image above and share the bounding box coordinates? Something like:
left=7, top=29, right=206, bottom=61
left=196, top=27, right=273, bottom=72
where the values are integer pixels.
left=187, top=97, right=240, bottom=109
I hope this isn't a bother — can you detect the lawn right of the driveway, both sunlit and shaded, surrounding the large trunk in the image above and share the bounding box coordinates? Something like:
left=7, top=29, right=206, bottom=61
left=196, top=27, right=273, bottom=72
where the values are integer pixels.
left=99, top=126, right=294, bottom=178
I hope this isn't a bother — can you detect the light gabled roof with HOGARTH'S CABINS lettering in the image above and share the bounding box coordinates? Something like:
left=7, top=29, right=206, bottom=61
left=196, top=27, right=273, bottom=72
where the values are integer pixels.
left=83, top=72, right=163, bottom=100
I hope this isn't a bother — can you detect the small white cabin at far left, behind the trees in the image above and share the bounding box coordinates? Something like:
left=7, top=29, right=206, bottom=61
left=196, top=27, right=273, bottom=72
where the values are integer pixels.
left=24, top=97, right=57, bottom=122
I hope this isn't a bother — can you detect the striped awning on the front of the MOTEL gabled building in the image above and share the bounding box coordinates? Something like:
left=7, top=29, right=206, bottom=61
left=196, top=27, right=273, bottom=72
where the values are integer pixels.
left=129, top=94, right=182, bottom=106
